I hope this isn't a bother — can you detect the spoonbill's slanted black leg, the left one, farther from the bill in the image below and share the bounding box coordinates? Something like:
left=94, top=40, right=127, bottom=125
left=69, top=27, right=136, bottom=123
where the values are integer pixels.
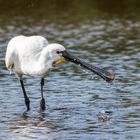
left=20, top=80, right=30, bottom=111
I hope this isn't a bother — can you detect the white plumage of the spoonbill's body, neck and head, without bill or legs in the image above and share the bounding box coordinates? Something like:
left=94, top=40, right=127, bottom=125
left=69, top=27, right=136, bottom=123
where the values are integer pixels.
left=5, top=36, right=65, bottom=78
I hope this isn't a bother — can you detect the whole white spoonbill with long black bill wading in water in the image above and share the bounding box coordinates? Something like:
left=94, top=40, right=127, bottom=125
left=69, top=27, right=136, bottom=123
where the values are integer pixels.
left=5, top=36, right=114, bottom=111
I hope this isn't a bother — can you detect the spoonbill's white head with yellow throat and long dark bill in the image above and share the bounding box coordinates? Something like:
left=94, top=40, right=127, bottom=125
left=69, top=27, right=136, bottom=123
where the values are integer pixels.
left=47, top=44, right=115, bottom=82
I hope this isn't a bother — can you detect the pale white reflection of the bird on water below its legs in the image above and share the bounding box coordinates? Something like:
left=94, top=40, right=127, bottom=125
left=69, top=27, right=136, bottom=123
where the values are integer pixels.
left=10, top=113, right=52, bottom=139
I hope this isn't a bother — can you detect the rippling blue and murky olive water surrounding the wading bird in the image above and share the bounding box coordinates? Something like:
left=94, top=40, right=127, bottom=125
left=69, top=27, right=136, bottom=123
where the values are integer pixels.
left=0, top=0, right=140, bottom=140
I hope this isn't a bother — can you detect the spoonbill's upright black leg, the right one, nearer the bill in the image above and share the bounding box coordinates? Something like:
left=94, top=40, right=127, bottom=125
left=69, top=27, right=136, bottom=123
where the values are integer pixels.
left=40, top=78, right=46, bottom=111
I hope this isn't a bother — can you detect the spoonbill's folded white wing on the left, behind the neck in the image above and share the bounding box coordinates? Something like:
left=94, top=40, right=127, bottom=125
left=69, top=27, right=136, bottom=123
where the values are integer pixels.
left=5, top=36, right=48, bottom=71
